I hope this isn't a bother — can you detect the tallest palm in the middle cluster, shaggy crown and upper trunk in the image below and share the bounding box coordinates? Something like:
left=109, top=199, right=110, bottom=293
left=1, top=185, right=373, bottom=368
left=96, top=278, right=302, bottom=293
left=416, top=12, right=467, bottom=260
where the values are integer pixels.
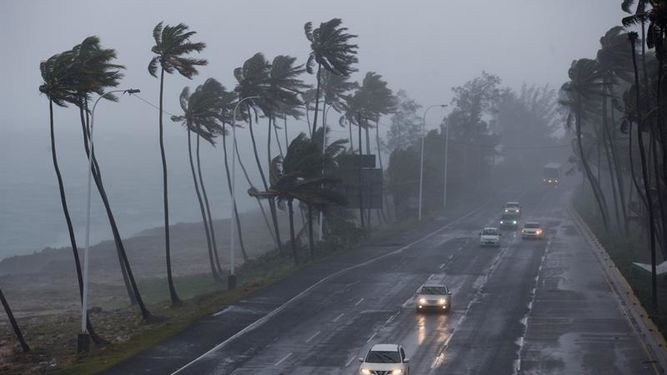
left=303, top=18, right=358, bottom=134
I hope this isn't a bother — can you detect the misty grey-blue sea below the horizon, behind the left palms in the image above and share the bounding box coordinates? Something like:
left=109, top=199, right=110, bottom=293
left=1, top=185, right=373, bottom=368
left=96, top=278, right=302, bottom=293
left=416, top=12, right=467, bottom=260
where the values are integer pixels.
left=0, top=123, right=256, bottom=259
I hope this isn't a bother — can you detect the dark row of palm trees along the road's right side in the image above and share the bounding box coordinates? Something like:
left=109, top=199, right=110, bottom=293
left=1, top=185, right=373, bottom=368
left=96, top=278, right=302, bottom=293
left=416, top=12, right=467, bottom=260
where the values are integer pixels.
left=561, top=0, right=667, bottom=308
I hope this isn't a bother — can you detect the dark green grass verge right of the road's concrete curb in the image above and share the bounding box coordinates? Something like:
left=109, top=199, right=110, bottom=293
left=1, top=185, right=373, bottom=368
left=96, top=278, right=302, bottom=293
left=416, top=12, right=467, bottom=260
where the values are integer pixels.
left=574, top=190, right=667, bottom=336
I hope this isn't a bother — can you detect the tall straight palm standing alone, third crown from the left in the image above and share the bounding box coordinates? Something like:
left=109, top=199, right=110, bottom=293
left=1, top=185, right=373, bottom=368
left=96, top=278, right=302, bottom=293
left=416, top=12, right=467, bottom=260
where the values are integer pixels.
left=148, top=22, right=207, bottom=305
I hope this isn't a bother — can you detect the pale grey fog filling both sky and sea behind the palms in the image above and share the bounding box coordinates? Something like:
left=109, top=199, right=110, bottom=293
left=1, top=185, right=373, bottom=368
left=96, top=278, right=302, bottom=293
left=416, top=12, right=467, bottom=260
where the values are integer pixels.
left=0, top=0, right=622, bottom=257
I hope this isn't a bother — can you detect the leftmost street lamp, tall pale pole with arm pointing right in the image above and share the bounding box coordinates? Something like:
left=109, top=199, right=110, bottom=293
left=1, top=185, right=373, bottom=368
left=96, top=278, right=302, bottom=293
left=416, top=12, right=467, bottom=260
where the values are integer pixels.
left=77, top=89, right=141, bottom=352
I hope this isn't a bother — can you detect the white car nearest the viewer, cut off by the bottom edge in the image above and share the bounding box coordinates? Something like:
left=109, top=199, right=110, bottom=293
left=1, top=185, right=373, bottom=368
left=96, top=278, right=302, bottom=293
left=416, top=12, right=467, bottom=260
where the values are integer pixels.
left=359, top=344, right=410, bottom=375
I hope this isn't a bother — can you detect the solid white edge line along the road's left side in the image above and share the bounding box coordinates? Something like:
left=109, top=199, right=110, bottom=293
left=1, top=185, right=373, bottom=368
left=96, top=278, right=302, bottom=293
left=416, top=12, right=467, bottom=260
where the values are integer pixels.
left=171, top=201, right=488, bottom=375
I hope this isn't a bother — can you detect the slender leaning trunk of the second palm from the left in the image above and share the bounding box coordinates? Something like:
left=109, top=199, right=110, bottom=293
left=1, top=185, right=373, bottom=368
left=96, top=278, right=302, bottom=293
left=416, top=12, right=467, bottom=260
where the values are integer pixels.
left=79, top=104, right=137, bottom=306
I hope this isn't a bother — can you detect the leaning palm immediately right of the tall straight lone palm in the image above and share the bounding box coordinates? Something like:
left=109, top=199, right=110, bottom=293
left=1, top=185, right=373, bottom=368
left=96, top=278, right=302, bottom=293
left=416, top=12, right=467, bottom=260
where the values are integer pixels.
left=171, top=86, right=222, bottom=282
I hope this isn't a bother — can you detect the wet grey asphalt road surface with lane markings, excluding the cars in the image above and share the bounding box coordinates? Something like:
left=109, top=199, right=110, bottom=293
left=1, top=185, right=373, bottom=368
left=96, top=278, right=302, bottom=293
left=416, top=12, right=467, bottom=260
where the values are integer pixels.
left=110, top=186, right=662, bottom=375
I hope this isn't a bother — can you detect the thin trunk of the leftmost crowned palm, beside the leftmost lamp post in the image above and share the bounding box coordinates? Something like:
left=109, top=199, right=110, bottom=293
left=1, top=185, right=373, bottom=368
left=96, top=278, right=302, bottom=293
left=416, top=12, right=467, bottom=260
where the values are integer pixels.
left=49, top=99, right=105, bottom=346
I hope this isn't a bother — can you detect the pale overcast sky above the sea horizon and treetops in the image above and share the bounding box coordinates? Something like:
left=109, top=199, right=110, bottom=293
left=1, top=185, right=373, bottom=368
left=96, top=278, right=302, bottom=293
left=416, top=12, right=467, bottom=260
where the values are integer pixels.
left=0, top=0, right=623, bottom=134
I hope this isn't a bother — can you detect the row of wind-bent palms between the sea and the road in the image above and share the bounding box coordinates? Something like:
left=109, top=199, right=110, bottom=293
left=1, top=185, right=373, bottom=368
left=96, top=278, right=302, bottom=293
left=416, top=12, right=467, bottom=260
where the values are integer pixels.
left=0, top=18, right=396, bottom=354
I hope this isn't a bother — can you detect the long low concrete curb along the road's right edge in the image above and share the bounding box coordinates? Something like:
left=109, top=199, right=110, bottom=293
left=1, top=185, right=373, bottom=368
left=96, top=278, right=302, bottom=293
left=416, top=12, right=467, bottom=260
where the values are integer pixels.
left=569, top=207, right=667, bottom=374
